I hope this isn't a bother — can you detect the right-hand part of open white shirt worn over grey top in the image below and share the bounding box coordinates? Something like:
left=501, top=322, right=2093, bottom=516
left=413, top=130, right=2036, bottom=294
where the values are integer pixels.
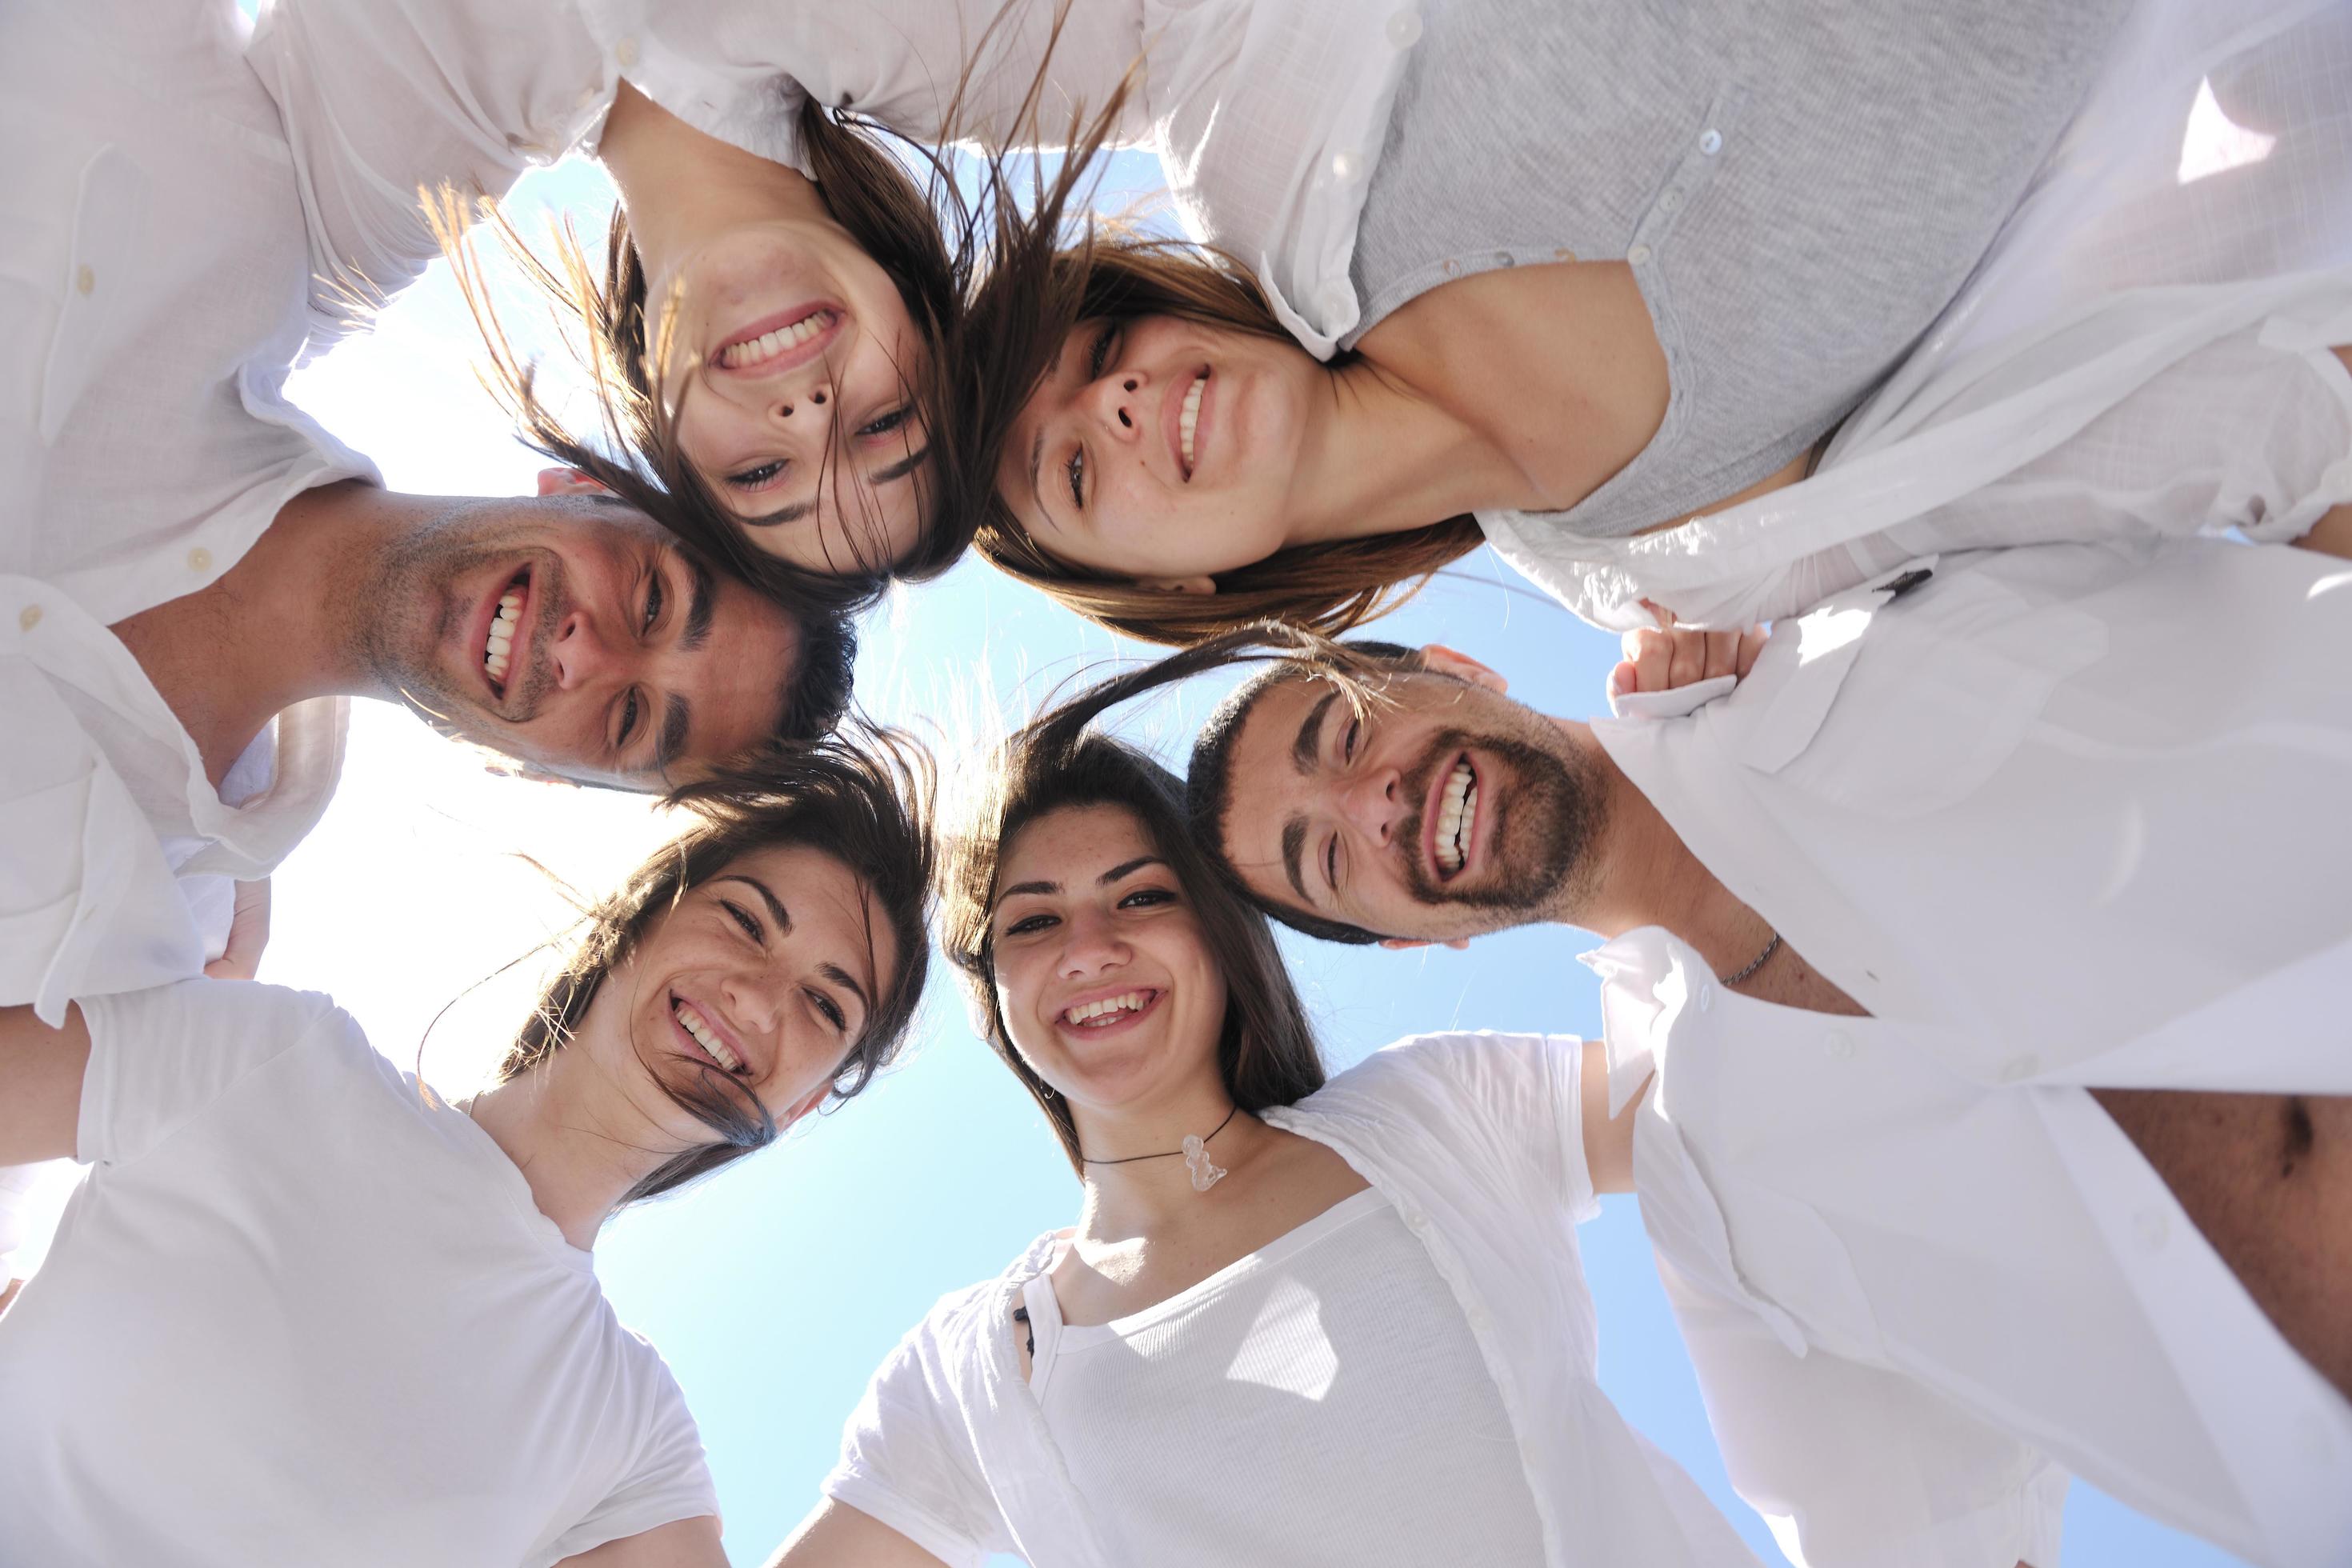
left=1479, top=0, right=2352, bottom=630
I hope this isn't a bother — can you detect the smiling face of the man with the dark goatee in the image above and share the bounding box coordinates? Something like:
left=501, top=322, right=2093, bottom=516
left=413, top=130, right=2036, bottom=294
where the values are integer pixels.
left=1221, top=672, right=1604, bottom=940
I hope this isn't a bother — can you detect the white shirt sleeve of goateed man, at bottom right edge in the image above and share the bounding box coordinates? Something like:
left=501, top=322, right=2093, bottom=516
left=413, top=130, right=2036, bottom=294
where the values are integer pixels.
left=1658, top=1258, right=2067, bottom=1568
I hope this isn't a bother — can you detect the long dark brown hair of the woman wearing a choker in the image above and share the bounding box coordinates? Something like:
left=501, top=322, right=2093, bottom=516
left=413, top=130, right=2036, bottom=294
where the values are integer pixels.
left=941, top=714, right=1324, bottom=1175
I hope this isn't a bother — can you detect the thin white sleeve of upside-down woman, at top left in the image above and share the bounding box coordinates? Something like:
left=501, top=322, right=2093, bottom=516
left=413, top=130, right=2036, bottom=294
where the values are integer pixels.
left=247, top=0, right=616, bottom=338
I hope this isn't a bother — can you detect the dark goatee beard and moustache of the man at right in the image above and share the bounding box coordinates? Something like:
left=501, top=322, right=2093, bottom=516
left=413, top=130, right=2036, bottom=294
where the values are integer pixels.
left=1399, top=729, right=1604, bottom=924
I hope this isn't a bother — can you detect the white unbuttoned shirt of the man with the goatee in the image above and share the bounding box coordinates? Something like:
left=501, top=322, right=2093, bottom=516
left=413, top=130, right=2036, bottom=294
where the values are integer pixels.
left=1594, top=541, right=2352, bottom=1568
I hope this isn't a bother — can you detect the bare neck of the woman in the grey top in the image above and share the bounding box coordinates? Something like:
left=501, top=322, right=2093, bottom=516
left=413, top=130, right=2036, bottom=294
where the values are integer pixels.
left=1284, top=360, right=1529, bottom=546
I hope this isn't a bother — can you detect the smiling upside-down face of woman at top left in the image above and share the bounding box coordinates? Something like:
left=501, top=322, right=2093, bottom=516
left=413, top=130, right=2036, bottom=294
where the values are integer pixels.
left=647, top=218, right=926, bottom=574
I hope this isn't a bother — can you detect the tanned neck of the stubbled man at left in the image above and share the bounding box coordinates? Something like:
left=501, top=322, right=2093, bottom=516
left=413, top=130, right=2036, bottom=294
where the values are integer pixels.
left=113, top=479, right=423, bottom=787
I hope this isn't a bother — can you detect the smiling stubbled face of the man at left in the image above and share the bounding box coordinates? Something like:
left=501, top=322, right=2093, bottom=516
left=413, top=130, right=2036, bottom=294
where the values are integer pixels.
left=362, top=498, right=800, bottom=790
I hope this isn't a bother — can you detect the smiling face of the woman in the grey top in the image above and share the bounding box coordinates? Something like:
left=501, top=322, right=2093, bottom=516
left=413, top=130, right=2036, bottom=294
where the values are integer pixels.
left=998, top=315, right=1326, bottom=586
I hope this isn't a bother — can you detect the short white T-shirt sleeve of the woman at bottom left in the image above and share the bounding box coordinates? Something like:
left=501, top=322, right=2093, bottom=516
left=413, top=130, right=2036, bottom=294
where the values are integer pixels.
left=73, top=980, right=343, bottom=1164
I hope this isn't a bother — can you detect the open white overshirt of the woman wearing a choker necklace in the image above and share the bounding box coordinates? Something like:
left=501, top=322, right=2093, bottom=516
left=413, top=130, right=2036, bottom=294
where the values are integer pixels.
left=826, top=1034, right=1754, bottom=1568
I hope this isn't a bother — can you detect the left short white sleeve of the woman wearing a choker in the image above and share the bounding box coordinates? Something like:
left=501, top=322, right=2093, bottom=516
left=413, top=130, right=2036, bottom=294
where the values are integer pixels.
left=823, top=1314, right=1014, bottom=1568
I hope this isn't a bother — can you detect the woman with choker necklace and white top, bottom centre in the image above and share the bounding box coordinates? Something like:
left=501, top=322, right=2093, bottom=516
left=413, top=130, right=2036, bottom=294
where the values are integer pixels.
left=776, top=717, right=1754, bottom=1568
